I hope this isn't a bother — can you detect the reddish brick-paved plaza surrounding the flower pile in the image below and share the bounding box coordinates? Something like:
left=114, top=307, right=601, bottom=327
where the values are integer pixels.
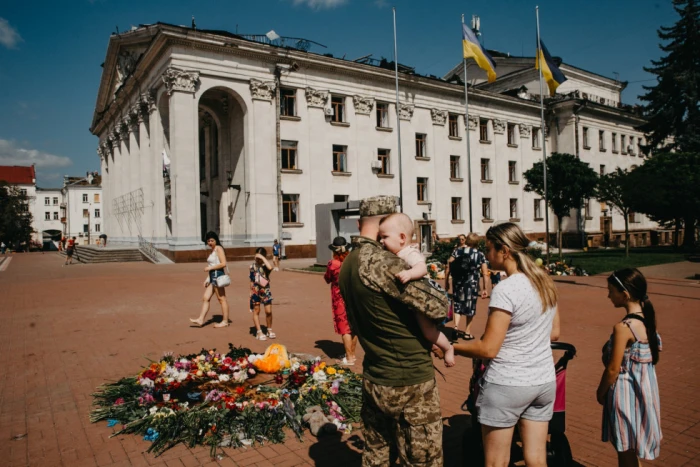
left=0, top=253, right=700, bottom=467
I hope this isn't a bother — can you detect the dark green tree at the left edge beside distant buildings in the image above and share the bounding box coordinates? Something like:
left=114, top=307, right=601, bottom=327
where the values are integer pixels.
left=0, top=181, right=32, bottom=246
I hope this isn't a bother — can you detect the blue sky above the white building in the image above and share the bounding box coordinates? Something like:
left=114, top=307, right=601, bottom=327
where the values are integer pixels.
left=0, top=0, right=677, bottom=187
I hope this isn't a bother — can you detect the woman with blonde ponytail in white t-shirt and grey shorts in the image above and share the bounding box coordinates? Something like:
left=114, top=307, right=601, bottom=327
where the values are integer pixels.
left=454, top=223, right=559, bottom=467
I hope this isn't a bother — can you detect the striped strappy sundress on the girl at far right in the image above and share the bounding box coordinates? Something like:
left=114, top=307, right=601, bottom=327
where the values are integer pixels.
left=603, top=321, right=662, bottom=460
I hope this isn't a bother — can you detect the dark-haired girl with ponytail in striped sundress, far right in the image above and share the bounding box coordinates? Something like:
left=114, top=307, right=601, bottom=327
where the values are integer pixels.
left=597, top=269, right=662, bottom=467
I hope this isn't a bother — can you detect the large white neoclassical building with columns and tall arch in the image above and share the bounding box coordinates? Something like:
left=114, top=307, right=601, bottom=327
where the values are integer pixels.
left=91, top=23, right=670, bottom=261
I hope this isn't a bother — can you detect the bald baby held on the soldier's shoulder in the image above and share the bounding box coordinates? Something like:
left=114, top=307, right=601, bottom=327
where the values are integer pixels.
left=379, top=213, right=455, bottom=367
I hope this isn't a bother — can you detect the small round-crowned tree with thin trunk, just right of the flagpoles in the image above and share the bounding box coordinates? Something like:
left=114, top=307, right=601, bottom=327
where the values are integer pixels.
left=523, top=152, right=598, bottom=258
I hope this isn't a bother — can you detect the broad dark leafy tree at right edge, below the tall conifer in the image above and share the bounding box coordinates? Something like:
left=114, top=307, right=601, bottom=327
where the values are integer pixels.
left=626, top=152, right=700, bottom=249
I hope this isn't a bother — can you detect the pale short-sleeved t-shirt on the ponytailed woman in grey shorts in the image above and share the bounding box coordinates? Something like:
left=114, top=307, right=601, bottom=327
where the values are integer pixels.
left=484, top=273, right=556, bottom=386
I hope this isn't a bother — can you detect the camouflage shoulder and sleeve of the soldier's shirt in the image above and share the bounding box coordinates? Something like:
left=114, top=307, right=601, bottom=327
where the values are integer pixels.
left=351, top=236, right=448, bottom=321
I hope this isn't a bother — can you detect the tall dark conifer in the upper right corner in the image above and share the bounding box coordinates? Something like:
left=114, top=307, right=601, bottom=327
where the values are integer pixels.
left=639, top=0, right=700, bottom=153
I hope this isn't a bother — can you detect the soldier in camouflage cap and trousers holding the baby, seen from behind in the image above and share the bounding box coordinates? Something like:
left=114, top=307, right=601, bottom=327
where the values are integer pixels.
left=338, top=196, right=447, bottom=467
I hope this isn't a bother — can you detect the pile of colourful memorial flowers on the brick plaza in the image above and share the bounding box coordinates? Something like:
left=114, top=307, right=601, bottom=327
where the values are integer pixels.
left=90, top=344, right=362, bottom=457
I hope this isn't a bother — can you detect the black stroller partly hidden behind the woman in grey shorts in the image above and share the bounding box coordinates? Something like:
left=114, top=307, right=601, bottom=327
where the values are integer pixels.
left=462, top=342, right=576, bottom=467
